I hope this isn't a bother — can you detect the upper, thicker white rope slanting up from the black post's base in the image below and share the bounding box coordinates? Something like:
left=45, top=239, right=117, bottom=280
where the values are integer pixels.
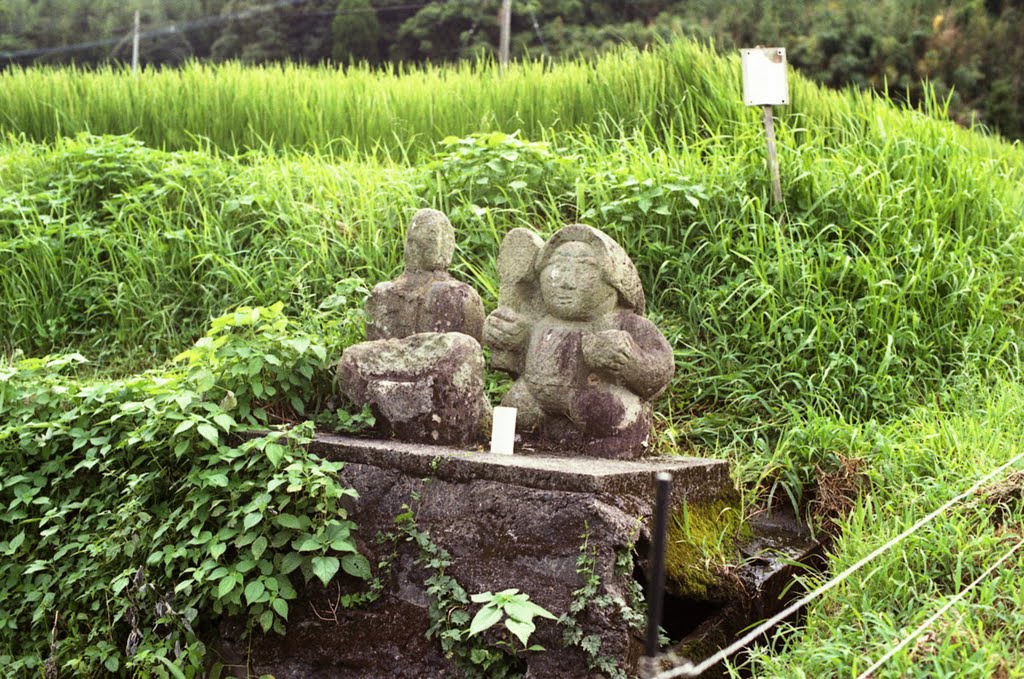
left=651, top=453, right=1024, bottom=679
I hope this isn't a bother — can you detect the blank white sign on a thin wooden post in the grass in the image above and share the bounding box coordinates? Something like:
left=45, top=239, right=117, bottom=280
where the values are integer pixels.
left=739, top=47, right=790, bottom=203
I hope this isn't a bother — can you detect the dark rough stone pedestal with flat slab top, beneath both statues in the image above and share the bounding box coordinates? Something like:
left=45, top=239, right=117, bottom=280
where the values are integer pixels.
left=211, top=435, right=733, bottom=679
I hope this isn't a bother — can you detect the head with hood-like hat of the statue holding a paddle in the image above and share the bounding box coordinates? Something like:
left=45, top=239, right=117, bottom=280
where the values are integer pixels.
left=538, top=224, right=644, bottom=321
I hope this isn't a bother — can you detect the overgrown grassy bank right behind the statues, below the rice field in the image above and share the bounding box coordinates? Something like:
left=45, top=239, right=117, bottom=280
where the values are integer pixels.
left=0, top=99, right=1024, bottom=440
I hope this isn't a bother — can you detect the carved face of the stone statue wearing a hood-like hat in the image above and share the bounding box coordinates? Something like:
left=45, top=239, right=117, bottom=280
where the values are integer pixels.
left=541, top=241, right=617, bottom=321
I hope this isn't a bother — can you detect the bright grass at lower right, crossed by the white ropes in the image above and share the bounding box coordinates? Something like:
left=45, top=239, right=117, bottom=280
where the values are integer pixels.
left=733, top=382, right=1024, bottom=678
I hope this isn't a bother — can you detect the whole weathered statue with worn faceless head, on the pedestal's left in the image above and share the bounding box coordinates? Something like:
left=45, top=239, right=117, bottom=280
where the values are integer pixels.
left=337, top=210, right=490, bottom=445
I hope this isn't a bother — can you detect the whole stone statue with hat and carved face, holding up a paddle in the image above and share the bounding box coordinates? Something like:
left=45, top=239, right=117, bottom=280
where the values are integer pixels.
left=483, top=224, right=675, bottom=458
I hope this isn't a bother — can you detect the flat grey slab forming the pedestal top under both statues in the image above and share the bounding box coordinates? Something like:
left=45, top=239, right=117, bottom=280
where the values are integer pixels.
left=310, top=433, right=732, bottom=502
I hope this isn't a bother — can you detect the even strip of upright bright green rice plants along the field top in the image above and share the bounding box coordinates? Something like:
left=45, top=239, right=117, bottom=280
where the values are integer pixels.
left=0, top=49, right=696, bottom=154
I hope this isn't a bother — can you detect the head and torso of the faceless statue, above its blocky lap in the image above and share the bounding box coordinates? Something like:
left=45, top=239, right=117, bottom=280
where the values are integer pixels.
left=367, top=209, right=483, bottom=342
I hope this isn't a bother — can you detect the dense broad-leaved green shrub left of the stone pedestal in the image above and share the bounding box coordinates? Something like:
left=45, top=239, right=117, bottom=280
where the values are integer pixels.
left=0, top=304, right=371, bottom=676
